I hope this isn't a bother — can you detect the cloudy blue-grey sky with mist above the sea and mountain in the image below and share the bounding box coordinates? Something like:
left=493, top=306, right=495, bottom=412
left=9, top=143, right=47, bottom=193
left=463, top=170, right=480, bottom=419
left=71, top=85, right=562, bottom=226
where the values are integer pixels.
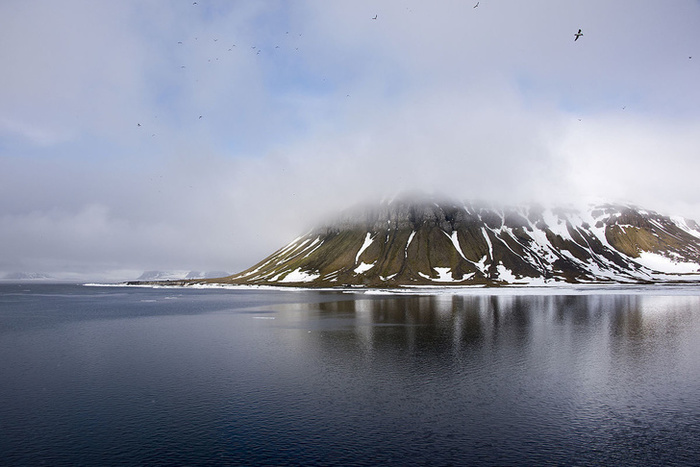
left=0, top=0, right=700, bottom=279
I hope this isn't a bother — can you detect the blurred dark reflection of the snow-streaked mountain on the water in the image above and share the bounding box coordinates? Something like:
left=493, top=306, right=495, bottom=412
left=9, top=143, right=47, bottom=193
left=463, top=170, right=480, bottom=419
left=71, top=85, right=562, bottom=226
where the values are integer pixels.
left=266, top=295, right=700, bottom=371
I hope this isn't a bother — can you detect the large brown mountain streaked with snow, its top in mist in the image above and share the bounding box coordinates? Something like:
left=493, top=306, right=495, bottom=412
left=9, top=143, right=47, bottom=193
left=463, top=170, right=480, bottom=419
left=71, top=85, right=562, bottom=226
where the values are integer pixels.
left=213, top=199, right=700, bottom=287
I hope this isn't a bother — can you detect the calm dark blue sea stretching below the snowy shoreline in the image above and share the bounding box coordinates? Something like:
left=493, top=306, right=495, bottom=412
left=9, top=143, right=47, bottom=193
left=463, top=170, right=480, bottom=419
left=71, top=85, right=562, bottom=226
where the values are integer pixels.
left=0, top=284, right=700, bottom=465
